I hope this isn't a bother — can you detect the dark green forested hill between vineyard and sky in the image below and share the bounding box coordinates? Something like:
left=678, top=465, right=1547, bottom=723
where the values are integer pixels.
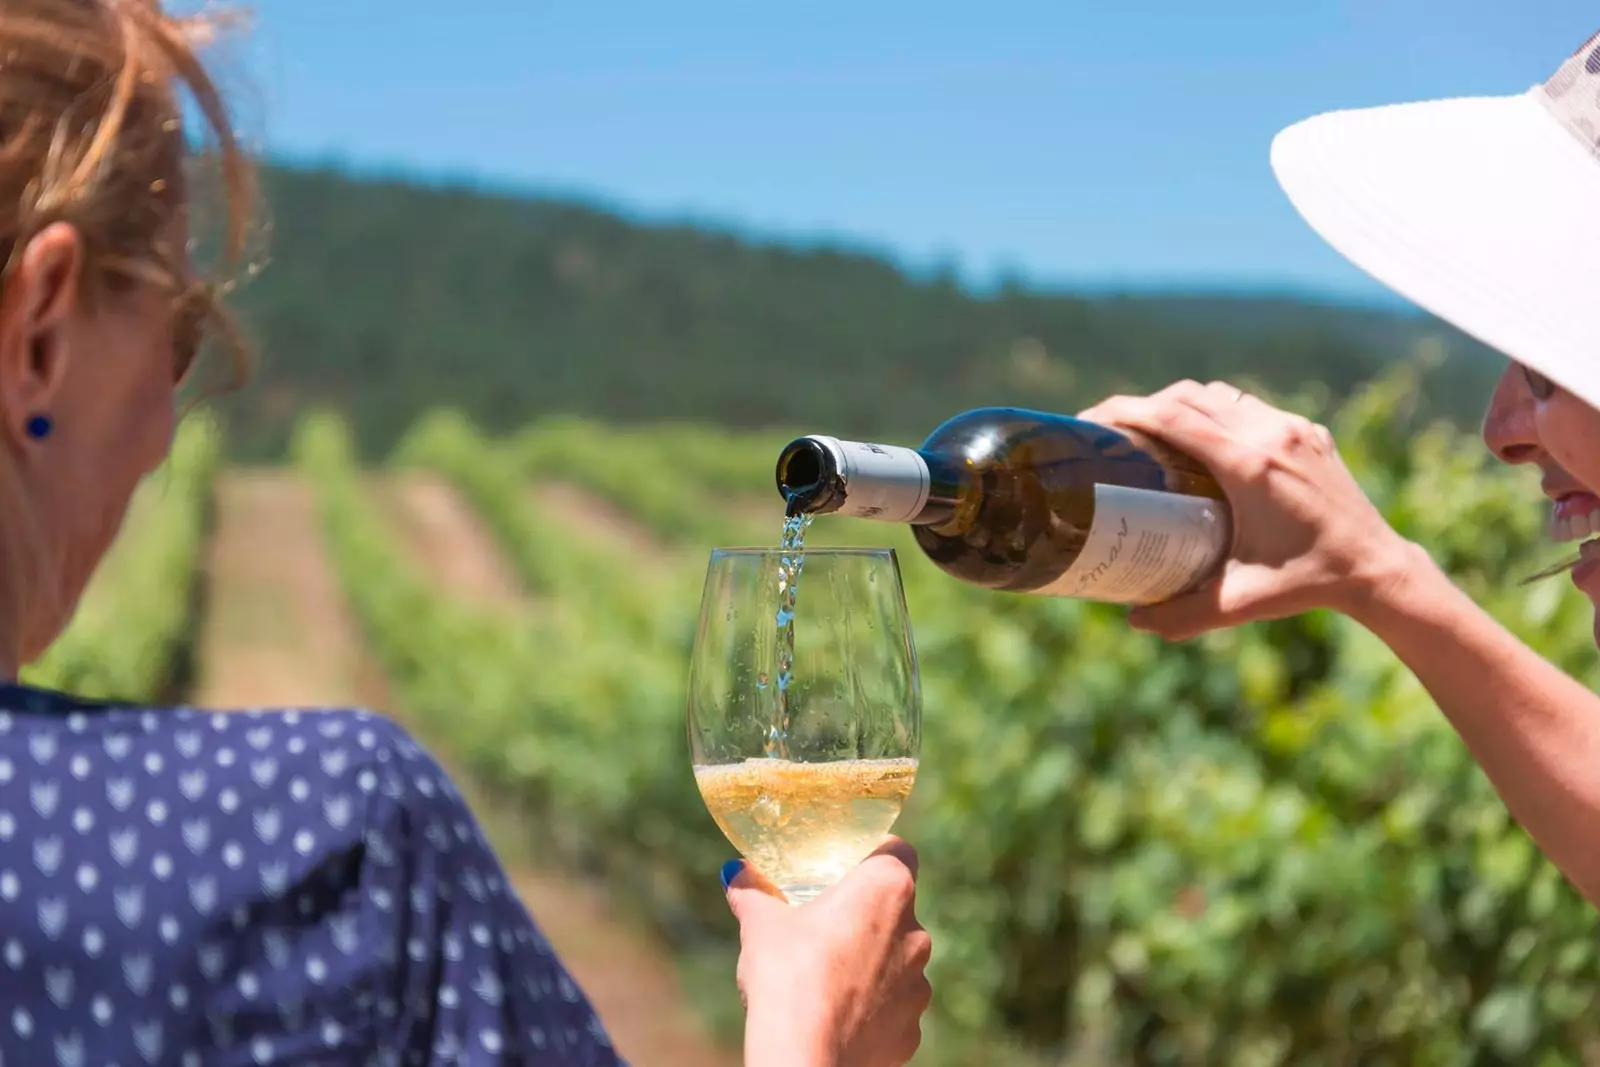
left=226, top=170, right=1498, bottom=454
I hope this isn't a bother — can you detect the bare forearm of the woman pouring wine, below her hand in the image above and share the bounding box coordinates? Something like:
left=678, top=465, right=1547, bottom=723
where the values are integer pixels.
left=1346, top=545, right=1600, bottom=904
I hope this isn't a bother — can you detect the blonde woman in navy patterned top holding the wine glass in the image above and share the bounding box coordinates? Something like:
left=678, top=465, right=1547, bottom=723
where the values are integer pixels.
left=0, top=0, right=928, bottom=1067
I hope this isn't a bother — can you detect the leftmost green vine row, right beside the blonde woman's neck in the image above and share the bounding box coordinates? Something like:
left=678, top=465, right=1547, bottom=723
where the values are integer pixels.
left=21, top=413, right=221, bottom=702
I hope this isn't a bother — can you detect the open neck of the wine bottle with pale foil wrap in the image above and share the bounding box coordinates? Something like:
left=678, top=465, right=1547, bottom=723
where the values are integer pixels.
left=778, top=435, right=965, bottom=525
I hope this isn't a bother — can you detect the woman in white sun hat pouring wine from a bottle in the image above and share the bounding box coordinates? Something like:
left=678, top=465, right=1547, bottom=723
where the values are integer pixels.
left=1085, top=34, right=1600, bottom=904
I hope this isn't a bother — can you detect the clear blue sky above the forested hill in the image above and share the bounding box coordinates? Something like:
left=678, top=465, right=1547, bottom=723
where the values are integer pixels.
left=242, top=0, right=1600, bottom=299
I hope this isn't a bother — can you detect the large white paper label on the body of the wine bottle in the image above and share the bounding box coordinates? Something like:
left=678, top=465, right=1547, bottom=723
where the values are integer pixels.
left=1035, top=483, right=1232, bottom=605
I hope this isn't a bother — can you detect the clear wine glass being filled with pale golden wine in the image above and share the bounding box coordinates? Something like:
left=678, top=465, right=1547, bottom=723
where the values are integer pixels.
left=688, top=547, right=922, bottom=904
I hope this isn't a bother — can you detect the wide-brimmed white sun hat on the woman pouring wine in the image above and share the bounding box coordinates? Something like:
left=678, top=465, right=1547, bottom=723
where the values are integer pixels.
left=1272, top=34, right=1600, bottom=408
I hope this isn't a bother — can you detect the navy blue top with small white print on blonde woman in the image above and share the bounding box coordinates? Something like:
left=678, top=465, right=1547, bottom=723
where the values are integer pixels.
left=0, top=685, right=622, bottom=1067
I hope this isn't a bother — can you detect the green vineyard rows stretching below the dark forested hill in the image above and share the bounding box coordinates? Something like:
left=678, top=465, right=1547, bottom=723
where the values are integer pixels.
left=26, top=361, right=1600, bottom=1067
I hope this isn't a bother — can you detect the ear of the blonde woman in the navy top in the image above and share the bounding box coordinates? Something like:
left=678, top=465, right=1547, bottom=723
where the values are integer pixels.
left=0, top=222, right=85, bottom=445
